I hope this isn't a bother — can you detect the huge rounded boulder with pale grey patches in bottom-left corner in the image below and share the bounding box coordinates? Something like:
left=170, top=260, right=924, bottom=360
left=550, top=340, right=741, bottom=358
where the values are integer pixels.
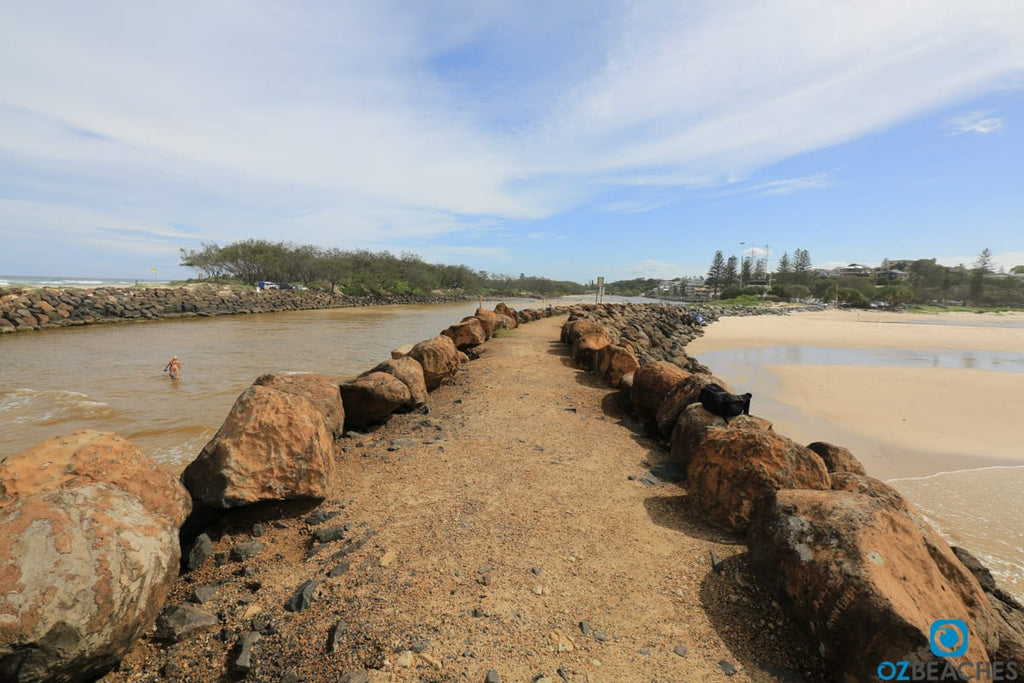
left=0, top=430, right=191, bottom=683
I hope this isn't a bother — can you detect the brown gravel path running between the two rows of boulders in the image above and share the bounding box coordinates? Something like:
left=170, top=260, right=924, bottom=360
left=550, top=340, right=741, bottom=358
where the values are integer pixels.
left=105, top=318, right=820, bottom=683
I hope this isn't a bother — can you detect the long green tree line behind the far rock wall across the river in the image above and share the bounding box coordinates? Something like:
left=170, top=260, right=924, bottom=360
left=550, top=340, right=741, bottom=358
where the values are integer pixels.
left=180, top=240, right=584, bottom=296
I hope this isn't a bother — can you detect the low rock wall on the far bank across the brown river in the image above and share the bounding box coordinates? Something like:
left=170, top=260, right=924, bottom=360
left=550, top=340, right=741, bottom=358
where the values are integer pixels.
left=0, top=285, right=475, bottom=334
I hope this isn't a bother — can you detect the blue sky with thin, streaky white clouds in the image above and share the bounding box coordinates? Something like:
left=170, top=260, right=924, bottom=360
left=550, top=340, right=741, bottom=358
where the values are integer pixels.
left=0, top=0, right=1024, bottom=282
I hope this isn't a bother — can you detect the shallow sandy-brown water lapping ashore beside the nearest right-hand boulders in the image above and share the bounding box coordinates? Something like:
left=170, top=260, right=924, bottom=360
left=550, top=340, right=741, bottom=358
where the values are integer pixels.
left=889, top=467, right=1024, bottom=600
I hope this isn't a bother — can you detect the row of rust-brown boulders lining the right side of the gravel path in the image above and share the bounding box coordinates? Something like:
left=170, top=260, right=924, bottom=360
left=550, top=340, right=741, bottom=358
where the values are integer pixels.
left=561, top=306, right=1024, bottom=681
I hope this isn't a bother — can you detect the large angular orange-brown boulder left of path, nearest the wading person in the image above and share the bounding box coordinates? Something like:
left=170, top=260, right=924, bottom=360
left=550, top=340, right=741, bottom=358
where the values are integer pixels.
left=181, top=385, right=331, bottom=508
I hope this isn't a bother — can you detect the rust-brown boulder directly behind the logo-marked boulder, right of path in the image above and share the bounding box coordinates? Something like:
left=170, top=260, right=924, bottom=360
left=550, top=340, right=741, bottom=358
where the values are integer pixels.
left=686, top=426, right=831, bottom=531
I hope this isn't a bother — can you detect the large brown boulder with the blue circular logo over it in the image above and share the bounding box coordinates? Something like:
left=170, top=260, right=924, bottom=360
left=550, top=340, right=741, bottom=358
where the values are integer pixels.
left=748, top=489, right=1021, bottom=681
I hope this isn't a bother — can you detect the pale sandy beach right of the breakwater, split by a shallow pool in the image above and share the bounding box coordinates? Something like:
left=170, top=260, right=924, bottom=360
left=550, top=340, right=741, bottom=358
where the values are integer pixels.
left=687, top=310, right=1024, bottom=478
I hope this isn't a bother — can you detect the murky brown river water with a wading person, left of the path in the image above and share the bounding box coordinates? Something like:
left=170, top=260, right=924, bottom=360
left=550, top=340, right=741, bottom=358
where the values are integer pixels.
left=0, top=302, right=516, bottom=469
